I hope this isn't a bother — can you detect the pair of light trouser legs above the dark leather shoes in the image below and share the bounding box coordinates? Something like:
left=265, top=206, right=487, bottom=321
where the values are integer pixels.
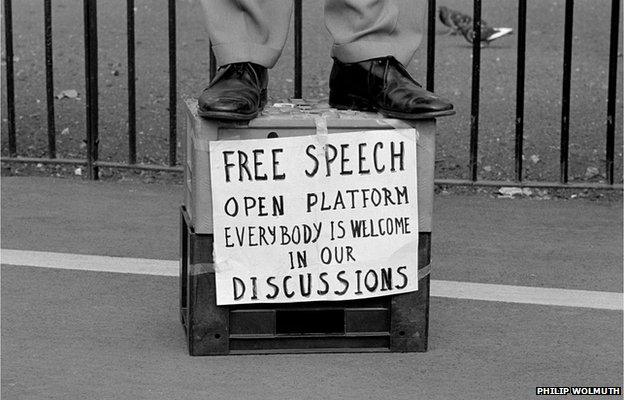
left=202, top=0, right=425, bottom=68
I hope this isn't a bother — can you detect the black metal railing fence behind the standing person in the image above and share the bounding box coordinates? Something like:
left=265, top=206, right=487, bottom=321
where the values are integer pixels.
left=0, top=0, right=622, bottom=190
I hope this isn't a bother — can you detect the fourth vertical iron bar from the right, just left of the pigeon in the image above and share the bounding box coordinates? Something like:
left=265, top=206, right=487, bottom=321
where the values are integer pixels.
left=470, top=0, right=481, bottom=181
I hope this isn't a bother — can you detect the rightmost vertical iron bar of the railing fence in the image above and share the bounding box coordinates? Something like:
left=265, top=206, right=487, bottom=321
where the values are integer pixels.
left=605, top=0, right=620, bottom=185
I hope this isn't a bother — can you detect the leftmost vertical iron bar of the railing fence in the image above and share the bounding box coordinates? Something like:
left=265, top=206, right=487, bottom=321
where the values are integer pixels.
left=4, top=0, right=17, bottom=157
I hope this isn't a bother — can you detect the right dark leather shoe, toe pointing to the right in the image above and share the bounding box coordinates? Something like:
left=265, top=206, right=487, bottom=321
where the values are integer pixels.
left=329, top=57, right=455, bottom=119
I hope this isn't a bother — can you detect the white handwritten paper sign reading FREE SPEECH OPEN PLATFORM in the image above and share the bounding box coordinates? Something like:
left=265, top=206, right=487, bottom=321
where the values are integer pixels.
left=210, top=129, right=418, bottom=305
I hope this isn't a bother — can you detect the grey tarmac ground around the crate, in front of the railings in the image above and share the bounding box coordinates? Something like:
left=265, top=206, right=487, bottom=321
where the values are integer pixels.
left=1, top=178, right=623, bottom=399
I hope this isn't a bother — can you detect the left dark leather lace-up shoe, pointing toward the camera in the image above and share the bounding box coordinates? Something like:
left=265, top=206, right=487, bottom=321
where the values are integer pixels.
left=197, top=62, right=269, bottom=121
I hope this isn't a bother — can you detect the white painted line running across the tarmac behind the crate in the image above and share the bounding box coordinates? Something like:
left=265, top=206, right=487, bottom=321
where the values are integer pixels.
left=0, top=249, right=624, bottom=310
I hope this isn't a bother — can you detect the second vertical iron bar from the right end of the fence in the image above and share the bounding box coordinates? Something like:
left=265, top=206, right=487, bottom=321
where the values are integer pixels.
left=559, top=0, right=574, bottom=183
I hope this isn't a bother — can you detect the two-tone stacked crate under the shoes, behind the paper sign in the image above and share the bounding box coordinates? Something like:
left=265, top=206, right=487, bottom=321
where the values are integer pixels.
left=180, top=101, right=435, bottom=355
